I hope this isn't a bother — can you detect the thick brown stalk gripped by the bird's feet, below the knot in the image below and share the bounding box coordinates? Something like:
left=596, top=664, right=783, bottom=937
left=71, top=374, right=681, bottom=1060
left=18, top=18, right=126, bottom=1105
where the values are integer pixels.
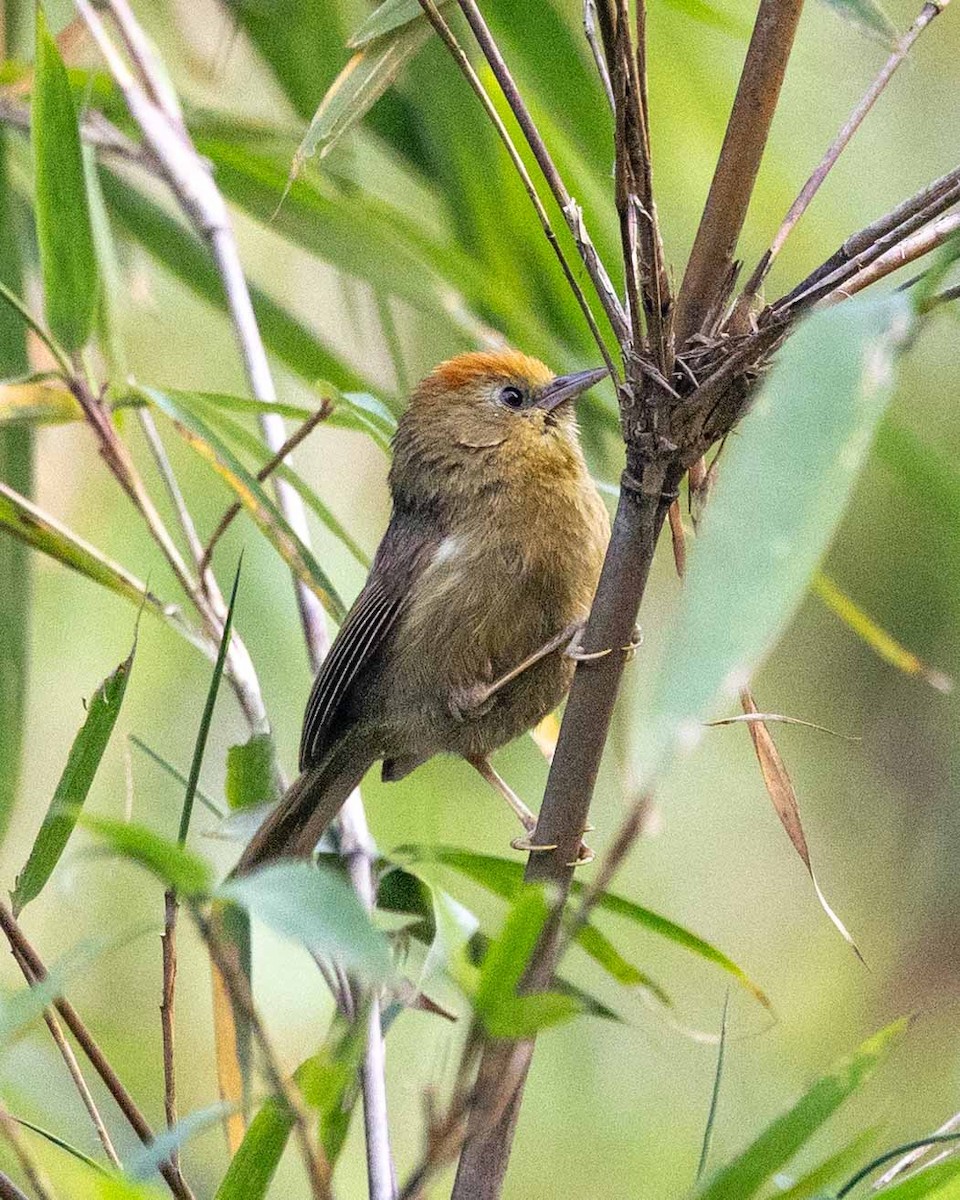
left=452, top=462, right=680, bottom=1200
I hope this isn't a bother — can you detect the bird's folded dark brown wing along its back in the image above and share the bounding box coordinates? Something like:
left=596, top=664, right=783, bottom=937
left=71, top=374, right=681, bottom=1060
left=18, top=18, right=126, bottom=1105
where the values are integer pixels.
left=300, top=514, right=439, bottom=770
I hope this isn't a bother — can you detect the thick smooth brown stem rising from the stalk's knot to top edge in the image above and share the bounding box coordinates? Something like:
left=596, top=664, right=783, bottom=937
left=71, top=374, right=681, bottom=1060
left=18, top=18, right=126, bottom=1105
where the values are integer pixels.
left=676, top=0, right=803, bottom=346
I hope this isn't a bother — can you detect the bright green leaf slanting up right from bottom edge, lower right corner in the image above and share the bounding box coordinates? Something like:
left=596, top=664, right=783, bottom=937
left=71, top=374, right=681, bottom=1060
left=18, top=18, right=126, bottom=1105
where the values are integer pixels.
left=696, top=1019, right=910, bottom=1200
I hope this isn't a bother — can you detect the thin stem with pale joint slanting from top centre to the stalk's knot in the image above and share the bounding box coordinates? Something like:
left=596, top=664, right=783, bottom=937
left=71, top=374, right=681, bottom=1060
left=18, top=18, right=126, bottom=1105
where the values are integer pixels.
left=458, top=0, right=630, bottom=346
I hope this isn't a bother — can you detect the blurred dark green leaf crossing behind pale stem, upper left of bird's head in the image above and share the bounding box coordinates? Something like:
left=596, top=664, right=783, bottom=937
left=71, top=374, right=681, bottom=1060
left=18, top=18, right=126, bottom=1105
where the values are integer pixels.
left=101, top=169, right=366, bottom=389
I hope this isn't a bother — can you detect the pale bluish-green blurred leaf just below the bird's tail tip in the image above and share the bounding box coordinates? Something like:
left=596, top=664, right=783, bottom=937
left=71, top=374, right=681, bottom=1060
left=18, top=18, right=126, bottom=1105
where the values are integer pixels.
left=216, top=862, right=391, bottom=982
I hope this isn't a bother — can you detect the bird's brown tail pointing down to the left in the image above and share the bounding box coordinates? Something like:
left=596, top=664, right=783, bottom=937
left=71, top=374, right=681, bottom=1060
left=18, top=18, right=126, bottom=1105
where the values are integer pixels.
left=234, top=745, right=373, bottom=875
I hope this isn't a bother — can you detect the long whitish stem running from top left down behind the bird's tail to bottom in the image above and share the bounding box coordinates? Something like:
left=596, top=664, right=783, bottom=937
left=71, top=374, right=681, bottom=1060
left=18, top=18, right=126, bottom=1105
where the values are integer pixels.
left=77, top=0, right=392, bottom=1195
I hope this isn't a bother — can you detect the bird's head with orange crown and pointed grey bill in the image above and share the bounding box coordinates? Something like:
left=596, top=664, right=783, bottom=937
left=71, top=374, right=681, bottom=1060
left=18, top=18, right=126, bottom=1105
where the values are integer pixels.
left=391, top=350, right=607, bottom=511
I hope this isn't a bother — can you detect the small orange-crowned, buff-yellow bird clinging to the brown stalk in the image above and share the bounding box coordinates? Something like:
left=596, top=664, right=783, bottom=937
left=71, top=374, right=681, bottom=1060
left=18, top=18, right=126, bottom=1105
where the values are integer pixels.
left=235, top=350, right=610, bottom=875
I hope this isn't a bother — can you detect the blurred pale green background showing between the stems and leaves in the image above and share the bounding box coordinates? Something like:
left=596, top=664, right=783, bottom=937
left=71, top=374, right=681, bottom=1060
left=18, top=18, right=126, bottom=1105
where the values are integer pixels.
left=0, top=0, right=960, bottom=1200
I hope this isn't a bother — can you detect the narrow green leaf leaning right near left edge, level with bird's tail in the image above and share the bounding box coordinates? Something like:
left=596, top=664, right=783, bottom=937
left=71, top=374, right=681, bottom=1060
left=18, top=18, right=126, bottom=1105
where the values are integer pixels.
left=11, top=638, right=137, bottom=916
